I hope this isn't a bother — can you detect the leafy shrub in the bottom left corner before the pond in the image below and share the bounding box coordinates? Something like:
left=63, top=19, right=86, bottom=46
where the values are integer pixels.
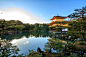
left=0, top=40, right=20, bottom=57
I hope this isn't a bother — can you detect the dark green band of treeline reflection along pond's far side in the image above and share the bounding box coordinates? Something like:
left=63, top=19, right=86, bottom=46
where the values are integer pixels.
left=0, top=31, right=50, bottom=41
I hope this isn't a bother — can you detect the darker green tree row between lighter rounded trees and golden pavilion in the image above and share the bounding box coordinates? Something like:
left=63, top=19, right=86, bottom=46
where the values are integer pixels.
left=23, top=23, right=49, bottom=31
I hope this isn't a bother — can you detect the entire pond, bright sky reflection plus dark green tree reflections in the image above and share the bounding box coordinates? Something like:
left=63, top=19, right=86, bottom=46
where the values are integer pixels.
left=0, top=31, right=73, bottom=55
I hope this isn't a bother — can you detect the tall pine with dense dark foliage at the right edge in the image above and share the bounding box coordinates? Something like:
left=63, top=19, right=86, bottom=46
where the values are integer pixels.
left=67, top=7, right=86, bottom=42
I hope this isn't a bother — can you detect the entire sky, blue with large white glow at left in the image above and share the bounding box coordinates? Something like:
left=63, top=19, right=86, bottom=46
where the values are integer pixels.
left=0, top=0, right=86, bottom=24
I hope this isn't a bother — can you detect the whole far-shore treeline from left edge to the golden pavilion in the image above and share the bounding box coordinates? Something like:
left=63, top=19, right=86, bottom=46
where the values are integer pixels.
left=0, top=20, right=49, bottom=34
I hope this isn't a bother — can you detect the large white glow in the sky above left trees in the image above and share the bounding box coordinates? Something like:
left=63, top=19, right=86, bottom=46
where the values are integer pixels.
left=0, top=8, right=46, bottom=24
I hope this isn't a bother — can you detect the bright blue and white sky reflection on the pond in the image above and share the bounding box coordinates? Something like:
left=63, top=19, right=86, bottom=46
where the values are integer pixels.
left=11, top=36, right=49, bottom=54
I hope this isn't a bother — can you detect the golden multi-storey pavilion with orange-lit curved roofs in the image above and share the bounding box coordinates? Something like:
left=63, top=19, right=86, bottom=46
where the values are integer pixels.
left=49, top=15, right=69, bottom=30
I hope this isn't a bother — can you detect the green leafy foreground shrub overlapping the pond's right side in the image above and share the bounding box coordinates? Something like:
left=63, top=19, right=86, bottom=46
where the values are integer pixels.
left=44, top=38, right=66, bottom=52
